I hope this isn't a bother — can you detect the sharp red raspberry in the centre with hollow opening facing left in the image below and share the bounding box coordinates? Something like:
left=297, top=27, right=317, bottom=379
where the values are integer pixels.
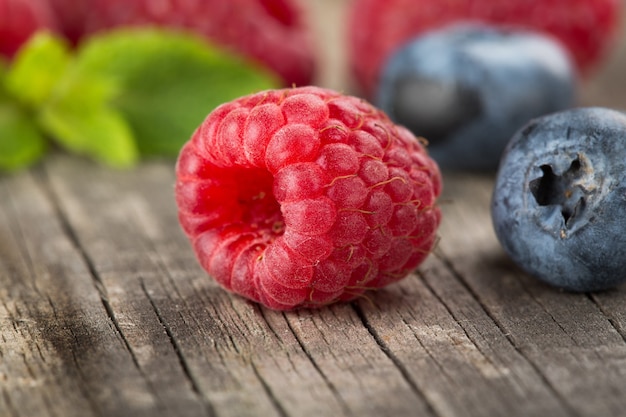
left=176, top=87, right=441, bottom=310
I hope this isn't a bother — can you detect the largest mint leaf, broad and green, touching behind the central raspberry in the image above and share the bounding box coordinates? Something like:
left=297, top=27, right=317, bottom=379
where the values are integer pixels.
left=72, top=28, right=280, bottom=156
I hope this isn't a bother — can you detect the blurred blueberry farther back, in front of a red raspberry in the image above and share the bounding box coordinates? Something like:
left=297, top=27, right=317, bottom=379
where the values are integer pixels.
left=375, top=23, right=577, bottom=171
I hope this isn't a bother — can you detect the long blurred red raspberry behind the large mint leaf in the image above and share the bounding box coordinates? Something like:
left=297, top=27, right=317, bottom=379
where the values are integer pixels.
left=50, top=0, right=314, bottom=85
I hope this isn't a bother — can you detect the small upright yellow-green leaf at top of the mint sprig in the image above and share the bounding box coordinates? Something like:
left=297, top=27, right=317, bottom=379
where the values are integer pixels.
left=4, top=32, right=71, bottom=108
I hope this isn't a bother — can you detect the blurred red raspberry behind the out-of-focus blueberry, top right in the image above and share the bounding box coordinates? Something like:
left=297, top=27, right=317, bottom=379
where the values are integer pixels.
left=348, top=0, right=621, bottom=96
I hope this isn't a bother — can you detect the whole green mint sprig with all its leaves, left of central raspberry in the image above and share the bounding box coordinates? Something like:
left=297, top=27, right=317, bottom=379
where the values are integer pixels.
left=0, top=28, right=280, bottom=170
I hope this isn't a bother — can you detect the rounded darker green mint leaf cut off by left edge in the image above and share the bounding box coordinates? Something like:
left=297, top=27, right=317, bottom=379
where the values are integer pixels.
left=0, top=97, right=46, bottom=171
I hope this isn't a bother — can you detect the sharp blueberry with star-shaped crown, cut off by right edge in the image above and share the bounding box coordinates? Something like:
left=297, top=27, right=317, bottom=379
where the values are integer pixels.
left=491, top=107, right=626, bottom=291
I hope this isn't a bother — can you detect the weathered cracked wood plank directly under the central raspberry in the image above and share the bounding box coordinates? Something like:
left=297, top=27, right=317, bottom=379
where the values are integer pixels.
left=42, top=158, right=434, bottom=415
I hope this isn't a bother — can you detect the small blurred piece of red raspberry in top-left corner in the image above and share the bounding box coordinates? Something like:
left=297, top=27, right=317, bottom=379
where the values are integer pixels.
left=0, top=0, right=56, bottom=59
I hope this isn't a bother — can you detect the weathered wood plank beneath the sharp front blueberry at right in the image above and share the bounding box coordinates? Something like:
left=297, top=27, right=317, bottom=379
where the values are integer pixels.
left=440, top=171, right=626, bottom=416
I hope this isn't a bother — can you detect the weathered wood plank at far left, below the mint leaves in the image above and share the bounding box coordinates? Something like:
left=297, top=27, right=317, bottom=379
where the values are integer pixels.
left=0, top=168, right=163, bottom=416
